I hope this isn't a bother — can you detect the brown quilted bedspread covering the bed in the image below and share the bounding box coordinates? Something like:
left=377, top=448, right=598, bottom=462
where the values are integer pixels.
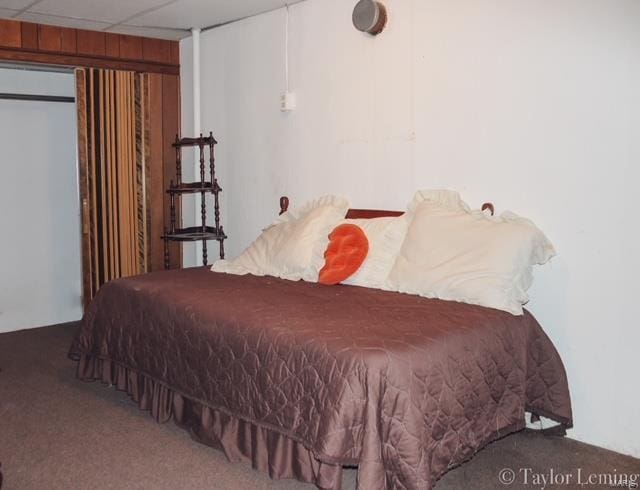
left=72, top=268, right=572, bottom=490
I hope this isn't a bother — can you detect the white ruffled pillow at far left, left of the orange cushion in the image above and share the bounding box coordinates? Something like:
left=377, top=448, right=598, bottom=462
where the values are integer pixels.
left=211, top=196, right=349, bottom=282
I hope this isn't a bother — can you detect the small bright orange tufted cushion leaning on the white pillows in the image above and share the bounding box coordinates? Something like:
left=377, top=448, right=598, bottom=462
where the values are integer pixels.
left=318, top=224, right=369, bottom=286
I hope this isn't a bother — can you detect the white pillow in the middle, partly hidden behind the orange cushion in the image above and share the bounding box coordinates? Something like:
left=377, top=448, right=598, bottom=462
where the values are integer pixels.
left=342, top=215, right=409, bottom=289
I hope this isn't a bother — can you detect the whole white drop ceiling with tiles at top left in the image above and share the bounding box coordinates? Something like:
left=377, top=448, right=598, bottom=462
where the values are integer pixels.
left=0, top=0, right=300, bottom=39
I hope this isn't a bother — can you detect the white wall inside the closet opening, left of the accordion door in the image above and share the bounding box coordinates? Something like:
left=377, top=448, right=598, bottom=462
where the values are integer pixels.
left=0, top=68, right=82, bottom=332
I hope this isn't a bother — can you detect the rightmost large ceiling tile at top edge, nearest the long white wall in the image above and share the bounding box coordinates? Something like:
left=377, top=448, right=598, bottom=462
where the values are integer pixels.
left=127, top=0, right=288, bottom=29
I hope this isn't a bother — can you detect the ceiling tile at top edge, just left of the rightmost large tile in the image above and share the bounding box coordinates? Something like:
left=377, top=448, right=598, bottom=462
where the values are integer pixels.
left=29, top=0, right=174, bottom=23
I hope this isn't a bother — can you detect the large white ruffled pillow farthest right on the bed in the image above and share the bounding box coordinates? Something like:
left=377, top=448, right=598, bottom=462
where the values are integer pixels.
left=388, top=191, right=555, bottom=315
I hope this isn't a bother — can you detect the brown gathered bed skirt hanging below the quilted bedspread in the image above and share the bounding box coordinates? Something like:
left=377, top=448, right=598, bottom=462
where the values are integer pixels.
left=70, top=354, right=342, bottom=490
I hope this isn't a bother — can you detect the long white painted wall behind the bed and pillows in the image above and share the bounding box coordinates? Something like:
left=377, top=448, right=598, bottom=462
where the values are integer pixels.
left=183, top=0, right=640, bottom=456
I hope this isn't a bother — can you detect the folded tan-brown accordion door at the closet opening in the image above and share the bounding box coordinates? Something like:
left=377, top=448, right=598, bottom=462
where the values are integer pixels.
left=76, top=68, right=150, bottom=304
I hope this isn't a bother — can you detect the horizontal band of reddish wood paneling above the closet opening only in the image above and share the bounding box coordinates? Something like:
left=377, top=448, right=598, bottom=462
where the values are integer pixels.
left=0, top=19, right=180, bottom=75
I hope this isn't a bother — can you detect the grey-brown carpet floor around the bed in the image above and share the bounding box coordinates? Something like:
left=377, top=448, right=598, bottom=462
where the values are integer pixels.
left=0, top=324, right=640, bottom=490
